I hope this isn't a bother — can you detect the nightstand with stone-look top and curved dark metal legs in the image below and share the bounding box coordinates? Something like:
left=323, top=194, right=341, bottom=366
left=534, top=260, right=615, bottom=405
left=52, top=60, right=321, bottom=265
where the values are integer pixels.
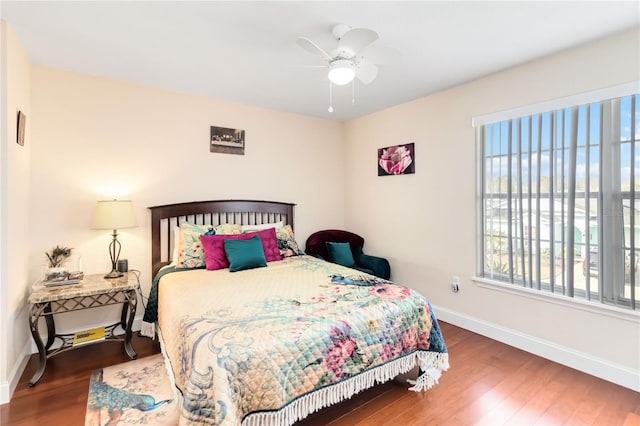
left=29, top=272, right=140, bottom=386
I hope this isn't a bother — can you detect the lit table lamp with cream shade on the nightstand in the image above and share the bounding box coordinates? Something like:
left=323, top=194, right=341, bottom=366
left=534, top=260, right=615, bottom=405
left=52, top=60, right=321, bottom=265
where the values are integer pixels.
left=91, top=200, right=138, bottom=278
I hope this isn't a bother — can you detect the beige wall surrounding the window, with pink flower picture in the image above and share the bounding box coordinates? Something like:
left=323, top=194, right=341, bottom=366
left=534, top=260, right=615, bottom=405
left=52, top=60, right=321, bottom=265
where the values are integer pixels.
left=344, top=27, right=640, bottom=387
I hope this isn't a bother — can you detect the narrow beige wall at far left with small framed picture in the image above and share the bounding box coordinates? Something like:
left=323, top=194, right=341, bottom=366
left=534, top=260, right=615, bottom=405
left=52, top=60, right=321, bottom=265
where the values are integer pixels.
left=0, top=21, right=33, bottom=400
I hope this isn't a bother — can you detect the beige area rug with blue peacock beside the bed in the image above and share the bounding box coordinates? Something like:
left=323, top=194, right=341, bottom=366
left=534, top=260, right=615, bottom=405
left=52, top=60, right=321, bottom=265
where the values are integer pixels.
left=84, top=354, right=179, bottom=426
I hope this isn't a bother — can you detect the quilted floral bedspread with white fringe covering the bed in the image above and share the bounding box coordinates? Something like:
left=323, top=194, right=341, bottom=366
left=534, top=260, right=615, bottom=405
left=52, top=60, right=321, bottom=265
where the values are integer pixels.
left=145, top=256, right=448, bottom=425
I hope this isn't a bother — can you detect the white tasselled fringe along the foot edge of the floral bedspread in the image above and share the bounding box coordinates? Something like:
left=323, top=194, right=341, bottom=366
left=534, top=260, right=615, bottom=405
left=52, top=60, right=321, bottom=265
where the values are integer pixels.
left=242, top=352, right=449, bottom=426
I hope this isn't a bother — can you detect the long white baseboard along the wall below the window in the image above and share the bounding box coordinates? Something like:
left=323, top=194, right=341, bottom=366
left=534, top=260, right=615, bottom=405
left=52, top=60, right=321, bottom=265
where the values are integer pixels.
left=433, top=305, right=640, bottom=392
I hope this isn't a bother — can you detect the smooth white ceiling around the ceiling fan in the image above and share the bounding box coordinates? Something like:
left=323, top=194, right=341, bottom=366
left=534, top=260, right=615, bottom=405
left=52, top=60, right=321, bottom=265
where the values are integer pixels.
left=0, top=0, right=640, bottom=121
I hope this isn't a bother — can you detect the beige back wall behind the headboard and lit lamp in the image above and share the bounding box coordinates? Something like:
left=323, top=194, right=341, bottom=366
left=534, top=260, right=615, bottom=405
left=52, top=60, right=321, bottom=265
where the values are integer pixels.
left=29, top=66, right=344, bottom=329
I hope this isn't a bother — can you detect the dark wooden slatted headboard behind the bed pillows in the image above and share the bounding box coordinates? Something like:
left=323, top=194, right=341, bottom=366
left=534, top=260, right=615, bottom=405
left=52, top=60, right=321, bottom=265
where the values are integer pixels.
left=149, top=200, right=295, bottom=277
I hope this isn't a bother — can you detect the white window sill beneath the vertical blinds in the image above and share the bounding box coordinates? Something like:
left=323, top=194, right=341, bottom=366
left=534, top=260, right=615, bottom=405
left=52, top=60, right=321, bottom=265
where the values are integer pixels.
left=472, top=276, right=640, bottom=323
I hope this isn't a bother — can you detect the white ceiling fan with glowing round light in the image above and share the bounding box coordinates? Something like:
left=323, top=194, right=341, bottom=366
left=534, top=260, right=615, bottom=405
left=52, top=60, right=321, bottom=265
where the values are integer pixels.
left=297, top=24, right=378, bottom=86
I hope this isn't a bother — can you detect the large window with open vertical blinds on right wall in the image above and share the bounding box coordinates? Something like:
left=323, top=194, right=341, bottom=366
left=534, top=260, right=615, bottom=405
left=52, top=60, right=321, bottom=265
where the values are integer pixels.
left=477, top=90, right=640, bottom=310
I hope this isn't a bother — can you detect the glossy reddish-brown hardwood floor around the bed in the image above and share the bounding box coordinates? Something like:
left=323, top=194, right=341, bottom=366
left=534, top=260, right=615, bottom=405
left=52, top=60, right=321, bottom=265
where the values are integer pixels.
left=0, top=322, right=640, bottom=426
